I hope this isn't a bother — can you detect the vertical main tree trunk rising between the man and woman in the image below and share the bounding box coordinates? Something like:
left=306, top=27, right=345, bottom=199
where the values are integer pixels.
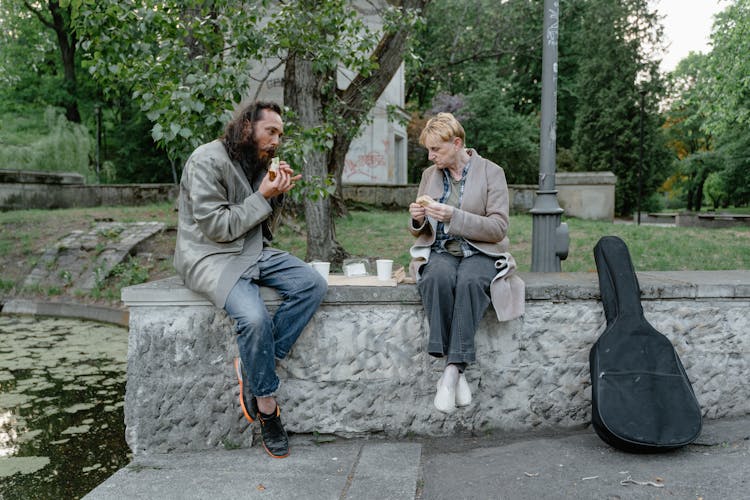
left=284, top=54, right=346, bottom=265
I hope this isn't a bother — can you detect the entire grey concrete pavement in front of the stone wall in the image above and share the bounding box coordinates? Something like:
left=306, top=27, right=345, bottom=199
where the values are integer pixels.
left=85, top=415, right=750, bottom=500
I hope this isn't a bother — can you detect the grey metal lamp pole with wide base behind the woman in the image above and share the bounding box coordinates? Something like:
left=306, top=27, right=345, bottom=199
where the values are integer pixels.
left=531, top=0, right=568, bottom=272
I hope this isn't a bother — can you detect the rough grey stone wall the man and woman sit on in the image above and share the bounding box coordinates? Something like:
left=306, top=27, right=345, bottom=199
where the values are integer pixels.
left=123, top=271, right=750, bottom=453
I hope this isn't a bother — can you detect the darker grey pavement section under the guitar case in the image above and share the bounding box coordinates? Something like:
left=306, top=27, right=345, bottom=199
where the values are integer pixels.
left=421, top=417, right=750, bottom=500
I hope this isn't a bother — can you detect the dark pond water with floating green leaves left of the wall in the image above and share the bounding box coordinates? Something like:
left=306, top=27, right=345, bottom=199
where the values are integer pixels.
left=0, top=315, right=131, bottom=499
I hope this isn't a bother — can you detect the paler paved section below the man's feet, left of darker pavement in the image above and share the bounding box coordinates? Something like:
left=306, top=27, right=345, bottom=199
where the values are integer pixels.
left=84, top=437, right=421, bottom=500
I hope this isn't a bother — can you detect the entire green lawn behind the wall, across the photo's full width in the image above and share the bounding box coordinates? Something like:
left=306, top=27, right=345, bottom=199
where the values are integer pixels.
left=0, top=203, right=750, bottom=302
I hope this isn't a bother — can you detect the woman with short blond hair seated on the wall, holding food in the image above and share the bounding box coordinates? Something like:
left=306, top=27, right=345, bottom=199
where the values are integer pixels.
left=409, top=113, right=509, bottom=413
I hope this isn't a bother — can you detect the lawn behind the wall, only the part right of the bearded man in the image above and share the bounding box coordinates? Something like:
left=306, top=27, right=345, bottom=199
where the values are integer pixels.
left=277, top=210, right=750, bottom=272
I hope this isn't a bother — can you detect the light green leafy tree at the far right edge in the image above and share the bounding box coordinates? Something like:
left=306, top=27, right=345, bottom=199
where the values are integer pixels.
left=665, top=0, right=750, bottom=211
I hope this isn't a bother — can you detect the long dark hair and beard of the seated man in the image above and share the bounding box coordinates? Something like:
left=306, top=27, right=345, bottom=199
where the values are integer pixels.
left=221, top=101, right=281, bottom=182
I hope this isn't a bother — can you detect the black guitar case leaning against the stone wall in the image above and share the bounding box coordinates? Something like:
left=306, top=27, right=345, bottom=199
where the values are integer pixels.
left=589, top=236, right=701, bottom=453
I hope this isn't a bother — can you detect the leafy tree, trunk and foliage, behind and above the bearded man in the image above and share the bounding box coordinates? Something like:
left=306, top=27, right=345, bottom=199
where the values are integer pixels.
left=69, top=0, right=428, bottom=262
